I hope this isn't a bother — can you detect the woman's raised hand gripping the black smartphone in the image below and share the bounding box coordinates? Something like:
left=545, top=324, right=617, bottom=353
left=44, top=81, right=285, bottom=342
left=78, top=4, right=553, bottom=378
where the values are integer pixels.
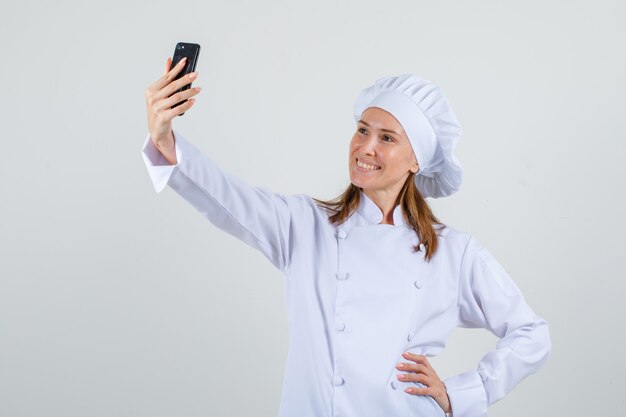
left=145, top=58, right=201, bottom=164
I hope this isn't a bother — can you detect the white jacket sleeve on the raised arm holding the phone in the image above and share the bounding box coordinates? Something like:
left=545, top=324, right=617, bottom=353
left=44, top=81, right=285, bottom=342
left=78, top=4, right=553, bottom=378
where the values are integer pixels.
left=142, top=131, right=303, bottom=273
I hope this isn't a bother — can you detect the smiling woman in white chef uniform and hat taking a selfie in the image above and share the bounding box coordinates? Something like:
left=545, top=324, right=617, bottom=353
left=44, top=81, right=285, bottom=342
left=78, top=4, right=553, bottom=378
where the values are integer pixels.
left=142, top=59, right=551, bottom=417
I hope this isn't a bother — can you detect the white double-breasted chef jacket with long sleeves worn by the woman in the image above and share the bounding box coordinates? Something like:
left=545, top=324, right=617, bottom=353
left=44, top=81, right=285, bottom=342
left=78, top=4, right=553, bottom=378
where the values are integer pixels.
left=142, top=131, right=551, bottom=417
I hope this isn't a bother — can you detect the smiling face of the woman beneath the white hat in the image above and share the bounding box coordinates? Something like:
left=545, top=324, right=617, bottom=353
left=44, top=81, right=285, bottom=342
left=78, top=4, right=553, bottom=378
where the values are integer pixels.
left=349, top=107, right=419, bottom=193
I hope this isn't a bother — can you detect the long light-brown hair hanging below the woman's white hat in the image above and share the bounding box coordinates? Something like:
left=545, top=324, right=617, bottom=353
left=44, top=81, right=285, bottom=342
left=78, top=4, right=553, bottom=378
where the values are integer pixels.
left=313, top=172, right=445, bottom=261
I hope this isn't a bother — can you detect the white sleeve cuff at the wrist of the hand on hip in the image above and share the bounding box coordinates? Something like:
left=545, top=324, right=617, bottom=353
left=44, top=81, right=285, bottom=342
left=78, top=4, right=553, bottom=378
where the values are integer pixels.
left=443, top=371, right=487, bottom=417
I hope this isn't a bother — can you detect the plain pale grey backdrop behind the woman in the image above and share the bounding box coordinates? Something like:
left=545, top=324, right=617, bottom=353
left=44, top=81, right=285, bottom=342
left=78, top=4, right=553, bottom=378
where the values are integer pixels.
left=0, top=0, right=626, bottom=417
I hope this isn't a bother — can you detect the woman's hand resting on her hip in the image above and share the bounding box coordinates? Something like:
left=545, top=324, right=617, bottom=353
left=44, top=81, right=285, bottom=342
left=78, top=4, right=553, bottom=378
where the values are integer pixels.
left=396, top=352, right=452, bottom=413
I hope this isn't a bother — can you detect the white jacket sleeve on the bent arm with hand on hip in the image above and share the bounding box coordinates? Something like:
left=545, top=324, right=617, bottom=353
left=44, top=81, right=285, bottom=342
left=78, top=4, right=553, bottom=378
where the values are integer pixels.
left=443, top=237, right=551, bottom=417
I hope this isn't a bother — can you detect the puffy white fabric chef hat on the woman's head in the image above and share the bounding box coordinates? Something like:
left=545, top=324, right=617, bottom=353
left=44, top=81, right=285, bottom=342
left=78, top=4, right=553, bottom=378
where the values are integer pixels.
left=354, top=74, right=463, bottom=198
